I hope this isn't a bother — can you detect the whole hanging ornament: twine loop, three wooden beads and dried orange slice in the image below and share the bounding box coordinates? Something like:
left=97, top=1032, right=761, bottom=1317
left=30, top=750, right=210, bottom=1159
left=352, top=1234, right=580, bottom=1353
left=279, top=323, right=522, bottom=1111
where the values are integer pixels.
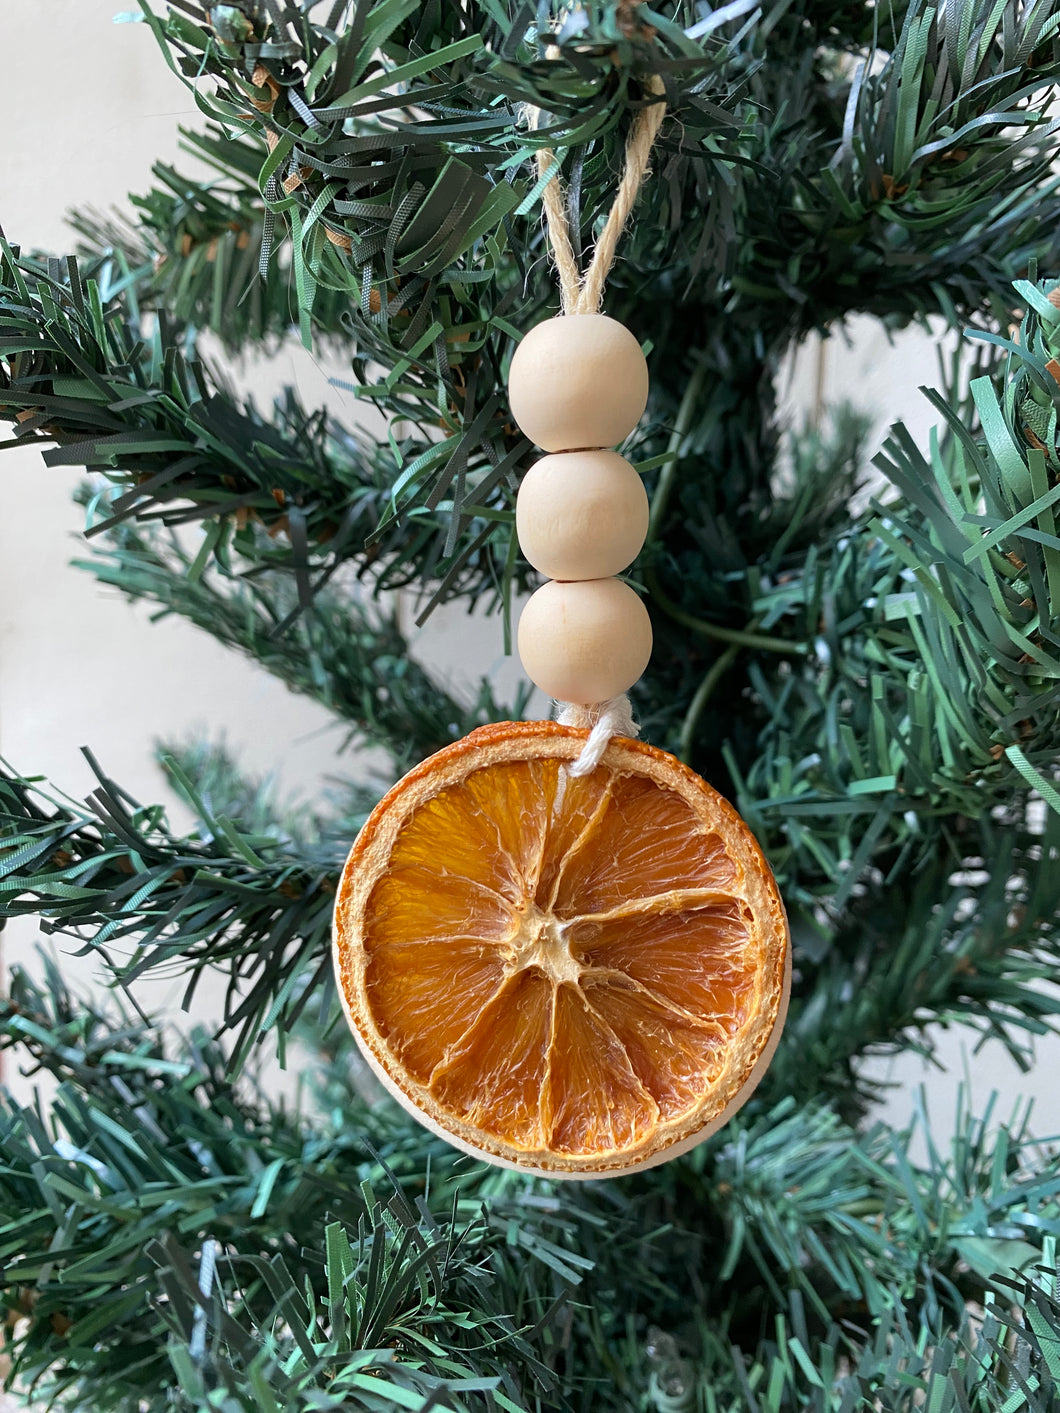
left=335, top=104, right=791, bottom=1178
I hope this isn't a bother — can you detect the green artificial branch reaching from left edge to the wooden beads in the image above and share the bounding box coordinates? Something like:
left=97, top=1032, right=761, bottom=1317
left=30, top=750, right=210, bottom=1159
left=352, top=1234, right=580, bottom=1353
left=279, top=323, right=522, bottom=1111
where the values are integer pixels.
left=0, top=242, right=526, bottom=605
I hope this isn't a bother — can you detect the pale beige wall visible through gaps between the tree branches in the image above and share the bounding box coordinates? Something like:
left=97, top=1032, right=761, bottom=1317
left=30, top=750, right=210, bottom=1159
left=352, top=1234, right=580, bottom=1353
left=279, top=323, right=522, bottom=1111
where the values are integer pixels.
left=0, top=0, right=1060, bottom=1133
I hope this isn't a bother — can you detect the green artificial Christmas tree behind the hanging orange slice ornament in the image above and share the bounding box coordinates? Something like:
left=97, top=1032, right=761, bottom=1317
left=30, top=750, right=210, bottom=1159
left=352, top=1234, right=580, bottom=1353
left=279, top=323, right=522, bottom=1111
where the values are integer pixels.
left=0, top=0, right=1060, bottom=1413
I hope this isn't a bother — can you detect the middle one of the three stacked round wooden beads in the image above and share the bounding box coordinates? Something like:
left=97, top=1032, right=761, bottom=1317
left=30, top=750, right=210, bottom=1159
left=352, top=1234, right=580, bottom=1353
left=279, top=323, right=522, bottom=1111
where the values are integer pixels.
left=516, top=451, right=647, bottom=579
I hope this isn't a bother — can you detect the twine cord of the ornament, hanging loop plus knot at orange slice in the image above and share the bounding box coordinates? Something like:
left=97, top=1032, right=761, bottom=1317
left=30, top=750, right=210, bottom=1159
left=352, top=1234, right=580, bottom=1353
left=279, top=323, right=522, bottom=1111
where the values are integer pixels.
left=527, top=73, right=666, bottom=776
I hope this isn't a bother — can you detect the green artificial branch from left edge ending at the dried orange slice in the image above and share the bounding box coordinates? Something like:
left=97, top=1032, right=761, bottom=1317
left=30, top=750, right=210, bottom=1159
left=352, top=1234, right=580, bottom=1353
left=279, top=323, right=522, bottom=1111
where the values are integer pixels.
left=0, top=756, right=343, bottom=1067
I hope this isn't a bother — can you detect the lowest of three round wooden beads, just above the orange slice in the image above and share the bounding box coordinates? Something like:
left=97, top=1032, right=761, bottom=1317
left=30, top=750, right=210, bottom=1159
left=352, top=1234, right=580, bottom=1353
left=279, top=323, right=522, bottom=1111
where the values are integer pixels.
left=519, top=579, right=652, bottom=707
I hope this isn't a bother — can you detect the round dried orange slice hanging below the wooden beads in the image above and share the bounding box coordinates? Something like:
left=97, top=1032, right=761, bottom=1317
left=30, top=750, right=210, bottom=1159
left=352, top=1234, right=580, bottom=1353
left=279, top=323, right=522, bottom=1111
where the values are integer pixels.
left=335, top=722, right=790, bottom=1177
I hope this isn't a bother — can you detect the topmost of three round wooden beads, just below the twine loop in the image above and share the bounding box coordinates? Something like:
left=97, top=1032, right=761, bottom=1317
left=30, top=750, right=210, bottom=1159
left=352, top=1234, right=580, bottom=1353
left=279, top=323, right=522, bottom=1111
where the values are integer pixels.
left=507, top=314, right=647, bottom=451
